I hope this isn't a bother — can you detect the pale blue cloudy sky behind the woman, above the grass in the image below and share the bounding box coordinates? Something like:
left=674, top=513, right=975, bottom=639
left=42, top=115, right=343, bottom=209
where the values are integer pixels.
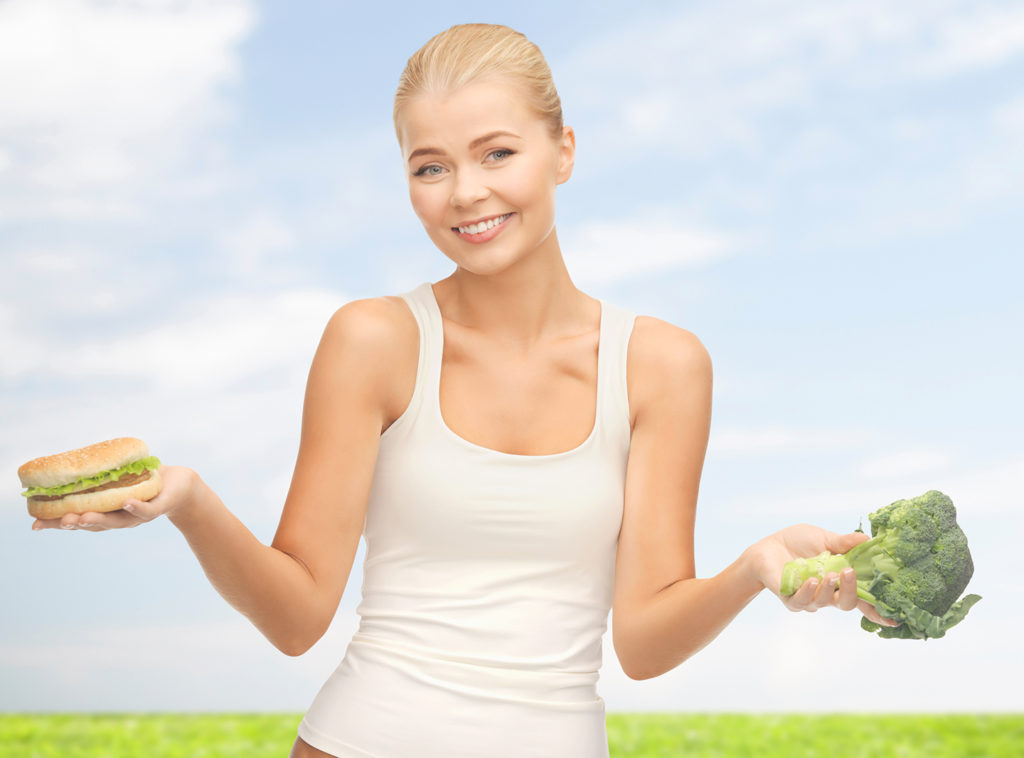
left=0, top=0, right=1024, bottom=712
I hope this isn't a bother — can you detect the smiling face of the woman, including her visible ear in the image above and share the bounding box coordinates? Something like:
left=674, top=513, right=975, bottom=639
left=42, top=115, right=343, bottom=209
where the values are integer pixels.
left=398, top=77, right=575, bottom=275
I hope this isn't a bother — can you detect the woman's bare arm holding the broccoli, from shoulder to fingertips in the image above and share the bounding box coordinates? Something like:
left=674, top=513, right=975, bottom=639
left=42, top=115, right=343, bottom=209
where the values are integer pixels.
left=612, top=318, right=881, bottom=679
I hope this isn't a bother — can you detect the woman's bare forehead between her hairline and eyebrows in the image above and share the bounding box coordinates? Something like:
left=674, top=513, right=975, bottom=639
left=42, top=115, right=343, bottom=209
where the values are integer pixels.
left=398, top=78, right=544, bottom=155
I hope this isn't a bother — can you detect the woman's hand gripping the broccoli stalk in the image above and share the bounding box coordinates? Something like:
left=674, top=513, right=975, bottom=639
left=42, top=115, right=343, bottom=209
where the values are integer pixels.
left=751, top=523, right=898, bottom=626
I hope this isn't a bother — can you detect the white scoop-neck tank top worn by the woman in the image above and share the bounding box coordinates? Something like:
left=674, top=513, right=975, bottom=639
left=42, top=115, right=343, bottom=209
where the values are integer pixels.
left=299, top=282, right=635, bottom=758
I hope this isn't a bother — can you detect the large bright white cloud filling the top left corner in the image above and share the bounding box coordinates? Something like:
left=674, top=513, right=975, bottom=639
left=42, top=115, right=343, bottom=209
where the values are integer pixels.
left=0, top=0, right=256, bottom=220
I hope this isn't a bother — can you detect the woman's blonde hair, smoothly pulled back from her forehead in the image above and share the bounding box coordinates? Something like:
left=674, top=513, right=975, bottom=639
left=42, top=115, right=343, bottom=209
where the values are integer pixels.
left=393, top=24, right=562, bottom=140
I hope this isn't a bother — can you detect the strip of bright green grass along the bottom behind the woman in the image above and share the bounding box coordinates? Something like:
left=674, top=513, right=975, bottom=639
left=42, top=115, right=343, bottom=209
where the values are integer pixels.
left=0, top=714, right=1024, bottom=758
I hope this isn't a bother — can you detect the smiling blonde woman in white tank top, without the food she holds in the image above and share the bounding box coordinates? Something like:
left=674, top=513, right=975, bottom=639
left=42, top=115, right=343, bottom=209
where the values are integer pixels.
left=41, top=25, right=883, bottom=758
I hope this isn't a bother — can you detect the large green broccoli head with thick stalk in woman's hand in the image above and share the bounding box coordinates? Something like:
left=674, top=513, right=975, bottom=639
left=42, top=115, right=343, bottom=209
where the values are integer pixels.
left=780, top=490, right=981, bottom=639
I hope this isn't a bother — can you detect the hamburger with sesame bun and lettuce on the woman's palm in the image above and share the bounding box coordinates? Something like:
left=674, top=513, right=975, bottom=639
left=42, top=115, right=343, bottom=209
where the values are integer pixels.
left=17, top=437, right=163, bottom=518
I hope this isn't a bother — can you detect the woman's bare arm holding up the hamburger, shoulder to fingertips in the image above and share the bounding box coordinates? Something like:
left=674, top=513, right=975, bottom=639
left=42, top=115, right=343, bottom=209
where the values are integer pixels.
left=36, top=299, right=400, bottom=655
